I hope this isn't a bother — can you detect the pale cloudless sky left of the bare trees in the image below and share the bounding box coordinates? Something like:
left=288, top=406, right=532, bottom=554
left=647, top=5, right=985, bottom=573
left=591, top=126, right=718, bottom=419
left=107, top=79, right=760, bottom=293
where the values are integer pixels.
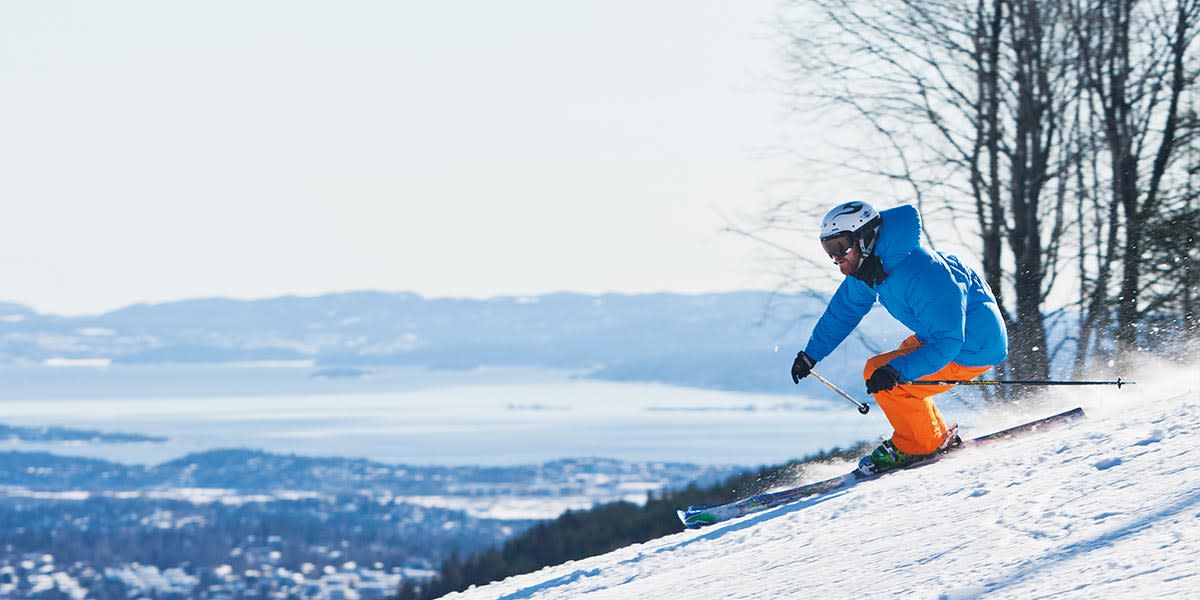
left=0, top=0, right=815, bottom=314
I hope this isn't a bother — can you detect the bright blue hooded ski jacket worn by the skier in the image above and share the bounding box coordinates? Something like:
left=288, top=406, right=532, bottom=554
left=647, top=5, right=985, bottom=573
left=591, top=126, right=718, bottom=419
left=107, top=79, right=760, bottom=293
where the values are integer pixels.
left=804, top=204, right=1008, bottom=380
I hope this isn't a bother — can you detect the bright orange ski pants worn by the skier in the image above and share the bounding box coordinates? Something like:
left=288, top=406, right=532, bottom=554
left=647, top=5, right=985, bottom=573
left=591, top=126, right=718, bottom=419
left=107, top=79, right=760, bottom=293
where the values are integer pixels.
left=863, top=336, right=991, bottom=455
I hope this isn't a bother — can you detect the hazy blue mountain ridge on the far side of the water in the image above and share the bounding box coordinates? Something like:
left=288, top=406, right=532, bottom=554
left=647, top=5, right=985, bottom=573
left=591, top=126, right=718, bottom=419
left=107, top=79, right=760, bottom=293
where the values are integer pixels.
left=0, top=292, right=904, bottom=392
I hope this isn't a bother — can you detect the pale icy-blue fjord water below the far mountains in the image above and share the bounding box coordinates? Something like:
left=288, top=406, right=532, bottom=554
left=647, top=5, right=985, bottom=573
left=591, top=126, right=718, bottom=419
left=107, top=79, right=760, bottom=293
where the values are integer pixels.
left=0, top=365, right=886, bottom=466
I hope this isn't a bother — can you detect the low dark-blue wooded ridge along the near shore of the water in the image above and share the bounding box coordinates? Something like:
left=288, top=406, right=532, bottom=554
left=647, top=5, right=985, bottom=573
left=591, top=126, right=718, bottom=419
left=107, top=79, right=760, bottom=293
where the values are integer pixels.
left=0, top=448, right=739, bottom=497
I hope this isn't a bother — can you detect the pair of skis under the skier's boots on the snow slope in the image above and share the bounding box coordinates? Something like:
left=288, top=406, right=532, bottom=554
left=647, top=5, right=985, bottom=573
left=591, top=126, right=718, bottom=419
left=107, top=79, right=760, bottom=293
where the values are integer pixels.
left=676, top=408, right=1084, bottom=529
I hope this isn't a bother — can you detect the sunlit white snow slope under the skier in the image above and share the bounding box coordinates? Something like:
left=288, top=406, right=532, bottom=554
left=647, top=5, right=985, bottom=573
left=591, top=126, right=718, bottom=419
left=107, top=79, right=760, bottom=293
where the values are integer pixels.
left=450, top=360, right=1200, bottom=600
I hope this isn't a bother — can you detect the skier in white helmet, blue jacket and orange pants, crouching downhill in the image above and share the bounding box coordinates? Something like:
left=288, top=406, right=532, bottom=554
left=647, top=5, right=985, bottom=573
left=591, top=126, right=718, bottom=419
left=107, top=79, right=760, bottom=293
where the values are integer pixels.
left=792, top=202, right=1008, bottom=474
